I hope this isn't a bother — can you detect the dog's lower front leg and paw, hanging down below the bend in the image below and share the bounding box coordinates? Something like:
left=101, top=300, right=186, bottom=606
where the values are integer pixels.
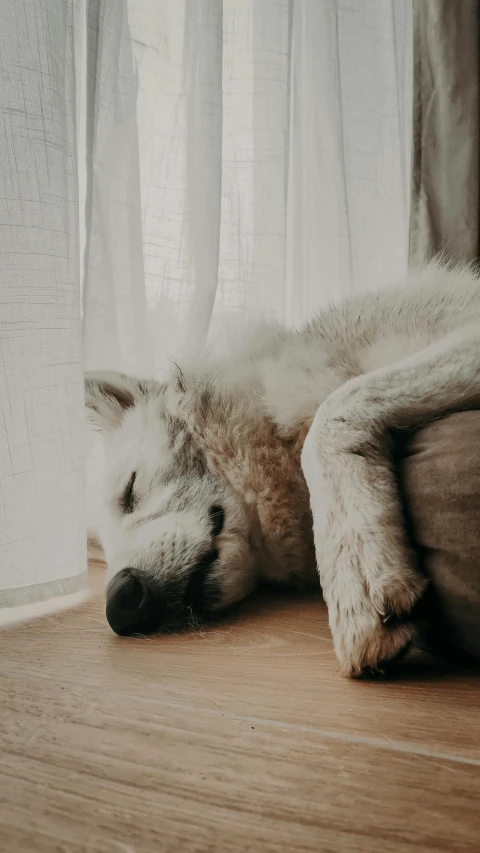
left=302, top=404, right=424, bottom=676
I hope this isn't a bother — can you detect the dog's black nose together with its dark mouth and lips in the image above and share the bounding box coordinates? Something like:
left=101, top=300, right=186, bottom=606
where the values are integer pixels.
left=106, top=548, right=218, bottom=636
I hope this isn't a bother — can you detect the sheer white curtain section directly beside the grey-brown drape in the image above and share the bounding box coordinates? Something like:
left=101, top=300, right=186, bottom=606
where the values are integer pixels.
left=286, top=0, right=412, bottom=325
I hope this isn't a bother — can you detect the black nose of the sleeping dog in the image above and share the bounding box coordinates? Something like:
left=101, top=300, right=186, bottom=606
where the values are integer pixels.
left=106, top=569, right=163, bottom=636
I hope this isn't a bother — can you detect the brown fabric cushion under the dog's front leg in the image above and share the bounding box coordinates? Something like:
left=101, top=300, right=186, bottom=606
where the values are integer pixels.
left=399, top=411, right=480, bottom=658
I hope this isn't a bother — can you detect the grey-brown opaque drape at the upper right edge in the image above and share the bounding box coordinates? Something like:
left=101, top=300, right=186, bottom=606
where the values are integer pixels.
left=410, top=0, right=480, bottom=265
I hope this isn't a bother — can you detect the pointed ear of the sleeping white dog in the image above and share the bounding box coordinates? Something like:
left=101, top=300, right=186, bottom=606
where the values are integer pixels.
left=85, top=371, right=145, bottom=432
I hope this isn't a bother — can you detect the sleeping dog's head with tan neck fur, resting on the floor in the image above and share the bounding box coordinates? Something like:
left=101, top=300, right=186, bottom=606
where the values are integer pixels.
left=85, top=373, right=314, bottom=634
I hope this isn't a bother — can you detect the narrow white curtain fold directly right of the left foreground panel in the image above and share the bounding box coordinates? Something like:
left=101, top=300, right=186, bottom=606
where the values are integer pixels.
left=83, top=0, right=151, bottom=375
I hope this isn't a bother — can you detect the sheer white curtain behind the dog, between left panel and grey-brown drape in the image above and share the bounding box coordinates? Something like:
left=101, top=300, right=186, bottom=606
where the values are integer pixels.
left=85, top=0, right=412, bottom=375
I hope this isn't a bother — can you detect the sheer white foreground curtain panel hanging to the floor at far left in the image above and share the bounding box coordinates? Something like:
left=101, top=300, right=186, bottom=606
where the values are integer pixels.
left=0, top=0, right=86, bottom=607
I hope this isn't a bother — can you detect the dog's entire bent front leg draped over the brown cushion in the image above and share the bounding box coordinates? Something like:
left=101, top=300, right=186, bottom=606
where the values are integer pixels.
left=302, top=327, right=480, bottom=675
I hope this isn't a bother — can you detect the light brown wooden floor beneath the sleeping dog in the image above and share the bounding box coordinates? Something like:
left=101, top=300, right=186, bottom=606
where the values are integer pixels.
left=0, top=564, right=480, bottom=853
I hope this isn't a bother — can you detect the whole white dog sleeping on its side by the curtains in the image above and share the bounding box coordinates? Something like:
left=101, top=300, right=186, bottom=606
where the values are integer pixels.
left=86, top=264, right=480, bottom=675
